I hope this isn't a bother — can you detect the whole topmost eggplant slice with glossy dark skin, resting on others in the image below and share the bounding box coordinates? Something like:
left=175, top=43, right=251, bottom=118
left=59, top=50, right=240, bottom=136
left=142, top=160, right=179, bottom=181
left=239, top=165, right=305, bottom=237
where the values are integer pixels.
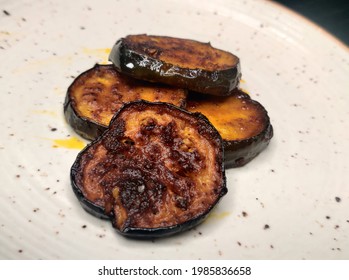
left=109, top=34, right=241, bottom=96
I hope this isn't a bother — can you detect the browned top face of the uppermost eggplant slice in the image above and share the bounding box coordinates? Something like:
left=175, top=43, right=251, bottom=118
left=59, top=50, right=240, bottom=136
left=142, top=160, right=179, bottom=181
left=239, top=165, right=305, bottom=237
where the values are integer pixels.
left=123, top=34, right=239, bottom=71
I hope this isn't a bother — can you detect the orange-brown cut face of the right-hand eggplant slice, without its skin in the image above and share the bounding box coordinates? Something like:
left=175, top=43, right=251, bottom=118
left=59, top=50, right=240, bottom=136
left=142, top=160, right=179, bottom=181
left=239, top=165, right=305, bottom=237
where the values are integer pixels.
left=187, top=90, right=269, bottom=141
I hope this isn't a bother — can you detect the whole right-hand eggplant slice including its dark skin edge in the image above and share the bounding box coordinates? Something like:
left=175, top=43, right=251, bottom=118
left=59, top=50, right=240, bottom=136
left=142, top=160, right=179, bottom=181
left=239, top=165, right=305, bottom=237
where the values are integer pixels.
left=187, top=89, right=273, bottom=168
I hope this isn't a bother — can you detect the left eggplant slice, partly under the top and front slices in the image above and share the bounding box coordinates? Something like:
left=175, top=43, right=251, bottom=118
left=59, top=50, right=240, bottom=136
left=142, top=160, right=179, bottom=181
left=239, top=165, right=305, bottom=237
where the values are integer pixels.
left=64, top=64, right=187, bottom=140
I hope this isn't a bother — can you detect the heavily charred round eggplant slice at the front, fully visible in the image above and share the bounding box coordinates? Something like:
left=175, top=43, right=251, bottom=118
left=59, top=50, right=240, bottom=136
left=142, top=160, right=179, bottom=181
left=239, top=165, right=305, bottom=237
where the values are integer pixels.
left=71, top=101, right=227, bottom=238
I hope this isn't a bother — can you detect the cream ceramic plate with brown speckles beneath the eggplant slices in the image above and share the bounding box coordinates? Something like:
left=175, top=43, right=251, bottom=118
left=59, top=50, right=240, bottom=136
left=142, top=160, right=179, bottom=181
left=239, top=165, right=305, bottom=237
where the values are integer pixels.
left=0, top=0, right=349, bottom=259
